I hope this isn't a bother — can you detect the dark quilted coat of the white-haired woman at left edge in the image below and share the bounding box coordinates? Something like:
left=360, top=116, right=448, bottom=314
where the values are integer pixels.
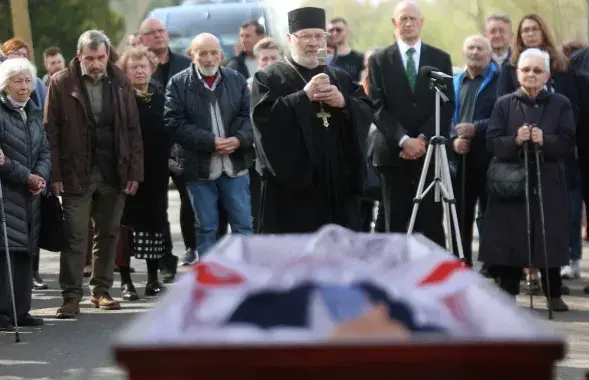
left=0, top=93, right=51, bottom=254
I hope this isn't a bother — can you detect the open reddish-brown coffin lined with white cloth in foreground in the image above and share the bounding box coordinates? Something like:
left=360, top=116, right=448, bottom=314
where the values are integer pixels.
left=114, top=226, right=565, bottom=380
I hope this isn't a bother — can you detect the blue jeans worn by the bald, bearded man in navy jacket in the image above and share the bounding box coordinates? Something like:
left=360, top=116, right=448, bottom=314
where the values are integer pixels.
left=186, top=174, right=253, bottom=257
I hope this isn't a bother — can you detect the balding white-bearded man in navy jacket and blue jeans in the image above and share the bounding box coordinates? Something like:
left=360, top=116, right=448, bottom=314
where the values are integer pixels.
left=164, top=33, right=254, bottom=255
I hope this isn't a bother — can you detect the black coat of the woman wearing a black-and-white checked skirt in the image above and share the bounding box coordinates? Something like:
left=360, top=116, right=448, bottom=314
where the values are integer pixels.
left=123, top=84, right=171, bottom=232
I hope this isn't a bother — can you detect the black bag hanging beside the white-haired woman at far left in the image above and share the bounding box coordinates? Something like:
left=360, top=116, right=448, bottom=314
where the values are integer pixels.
left=39, top=192, right=65, bottom=252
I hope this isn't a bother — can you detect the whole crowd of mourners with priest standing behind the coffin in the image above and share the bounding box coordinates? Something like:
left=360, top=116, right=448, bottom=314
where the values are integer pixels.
left=0, top=1, right=589, bottom=329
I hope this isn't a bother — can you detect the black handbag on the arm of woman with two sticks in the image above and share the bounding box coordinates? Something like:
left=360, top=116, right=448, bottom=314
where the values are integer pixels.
left=486, top=157, right=526, bottom=200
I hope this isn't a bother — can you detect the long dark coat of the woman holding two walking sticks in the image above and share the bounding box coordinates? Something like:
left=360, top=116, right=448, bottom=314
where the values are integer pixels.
left=479, top=90, right=576, bottom=268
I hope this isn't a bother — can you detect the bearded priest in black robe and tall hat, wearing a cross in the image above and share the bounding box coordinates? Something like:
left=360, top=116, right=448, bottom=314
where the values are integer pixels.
left=251, top=7, right=374, bottom=233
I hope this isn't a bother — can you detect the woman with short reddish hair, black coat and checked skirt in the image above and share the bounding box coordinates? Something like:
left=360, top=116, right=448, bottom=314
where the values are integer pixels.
left=117, top=46, right=171, bottom=301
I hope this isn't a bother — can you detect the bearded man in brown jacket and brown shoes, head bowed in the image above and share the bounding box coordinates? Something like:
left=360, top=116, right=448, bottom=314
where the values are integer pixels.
left=45, top=30, right=143, bottom=318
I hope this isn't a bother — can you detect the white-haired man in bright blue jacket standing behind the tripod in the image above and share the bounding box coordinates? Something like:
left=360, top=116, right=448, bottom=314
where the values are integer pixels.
left=450, top=35, right=499, bottom=265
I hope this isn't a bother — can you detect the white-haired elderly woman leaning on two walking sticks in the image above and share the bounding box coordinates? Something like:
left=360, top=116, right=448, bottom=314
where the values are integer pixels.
left=479, top=49, right=576, bottom=311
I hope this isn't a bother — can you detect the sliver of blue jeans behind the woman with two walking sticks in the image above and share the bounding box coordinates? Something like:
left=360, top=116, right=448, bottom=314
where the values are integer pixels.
left=567, top=162, right=583, bottom=260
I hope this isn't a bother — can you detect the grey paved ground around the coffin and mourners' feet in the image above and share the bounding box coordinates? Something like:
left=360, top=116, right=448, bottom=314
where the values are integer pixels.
left=0, top=191, right=589, bottom=380
